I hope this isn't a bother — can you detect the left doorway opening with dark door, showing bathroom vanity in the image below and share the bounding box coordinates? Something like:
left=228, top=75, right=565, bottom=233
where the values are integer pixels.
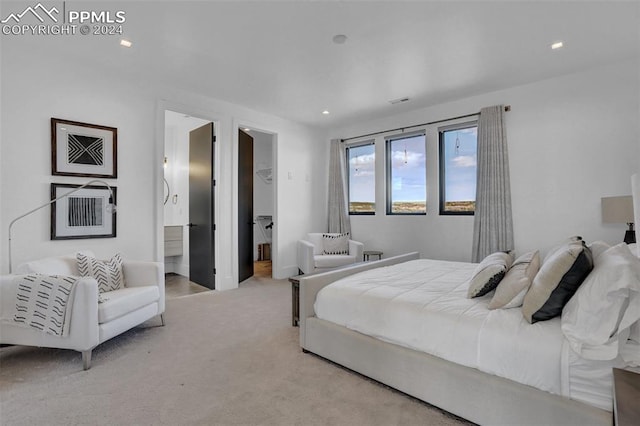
left=164, top=110, right=215, bottom=289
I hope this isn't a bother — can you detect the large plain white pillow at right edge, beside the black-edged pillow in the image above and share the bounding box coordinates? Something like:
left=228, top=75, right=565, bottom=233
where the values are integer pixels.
left=561, top=243, right=640, bottom=360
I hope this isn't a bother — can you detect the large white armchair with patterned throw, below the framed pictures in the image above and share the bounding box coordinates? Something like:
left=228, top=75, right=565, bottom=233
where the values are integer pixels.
left=0, top=252, right=165, bottom=370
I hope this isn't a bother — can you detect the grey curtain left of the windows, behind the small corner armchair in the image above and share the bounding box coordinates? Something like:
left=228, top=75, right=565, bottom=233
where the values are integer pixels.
left=329, top=139, right=351, bottom=232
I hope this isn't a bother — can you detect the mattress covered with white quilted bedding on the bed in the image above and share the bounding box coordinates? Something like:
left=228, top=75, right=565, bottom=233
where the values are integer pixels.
left=314, top=259, right=624, bottom=411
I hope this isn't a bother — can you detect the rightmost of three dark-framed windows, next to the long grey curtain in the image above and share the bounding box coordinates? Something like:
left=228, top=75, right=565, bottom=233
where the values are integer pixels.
left=439, top=122, right=478, bottom=215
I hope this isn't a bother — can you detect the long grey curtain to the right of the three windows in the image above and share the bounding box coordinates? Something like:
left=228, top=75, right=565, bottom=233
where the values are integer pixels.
left=472, top=105, right=513, bottom=262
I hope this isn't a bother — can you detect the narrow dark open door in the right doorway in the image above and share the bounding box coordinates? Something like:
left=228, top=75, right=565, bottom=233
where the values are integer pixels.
left=238, top=130, right=253, bottom=282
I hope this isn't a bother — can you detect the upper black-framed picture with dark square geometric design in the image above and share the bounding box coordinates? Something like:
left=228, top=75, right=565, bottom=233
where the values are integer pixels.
left=51, top=118, right=118, bottom=178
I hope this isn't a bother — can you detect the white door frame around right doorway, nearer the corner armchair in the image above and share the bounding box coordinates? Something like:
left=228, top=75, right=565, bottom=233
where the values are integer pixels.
left=232, top=119, right=280, bottom=282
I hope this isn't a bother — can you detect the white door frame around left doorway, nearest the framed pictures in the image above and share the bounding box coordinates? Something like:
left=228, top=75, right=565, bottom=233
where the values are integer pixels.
left=154, top=100, right=220, bottom=282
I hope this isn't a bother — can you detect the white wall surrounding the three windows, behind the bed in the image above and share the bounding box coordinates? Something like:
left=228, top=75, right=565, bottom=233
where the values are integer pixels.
left=329, top=61, right=640, bottom=261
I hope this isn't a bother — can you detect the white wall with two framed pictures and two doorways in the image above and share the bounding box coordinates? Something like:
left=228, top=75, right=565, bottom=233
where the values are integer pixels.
left=0, top=37, right=328, bottom=289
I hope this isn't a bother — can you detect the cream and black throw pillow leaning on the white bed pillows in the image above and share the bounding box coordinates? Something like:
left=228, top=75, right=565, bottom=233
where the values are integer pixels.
left=522, top=240, right=593, bottom=324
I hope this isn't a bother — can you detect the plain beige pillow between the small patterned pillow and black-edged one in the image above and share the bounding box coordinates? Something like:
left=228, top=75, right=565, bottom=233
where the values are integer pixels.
left=489, top=250, right=540, bottom=309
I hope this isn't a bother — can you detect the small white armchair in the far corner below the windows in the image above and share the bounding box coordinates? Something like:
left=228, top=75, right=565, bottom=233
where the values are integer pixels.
left=298, top=232, right=364, bottom=274
